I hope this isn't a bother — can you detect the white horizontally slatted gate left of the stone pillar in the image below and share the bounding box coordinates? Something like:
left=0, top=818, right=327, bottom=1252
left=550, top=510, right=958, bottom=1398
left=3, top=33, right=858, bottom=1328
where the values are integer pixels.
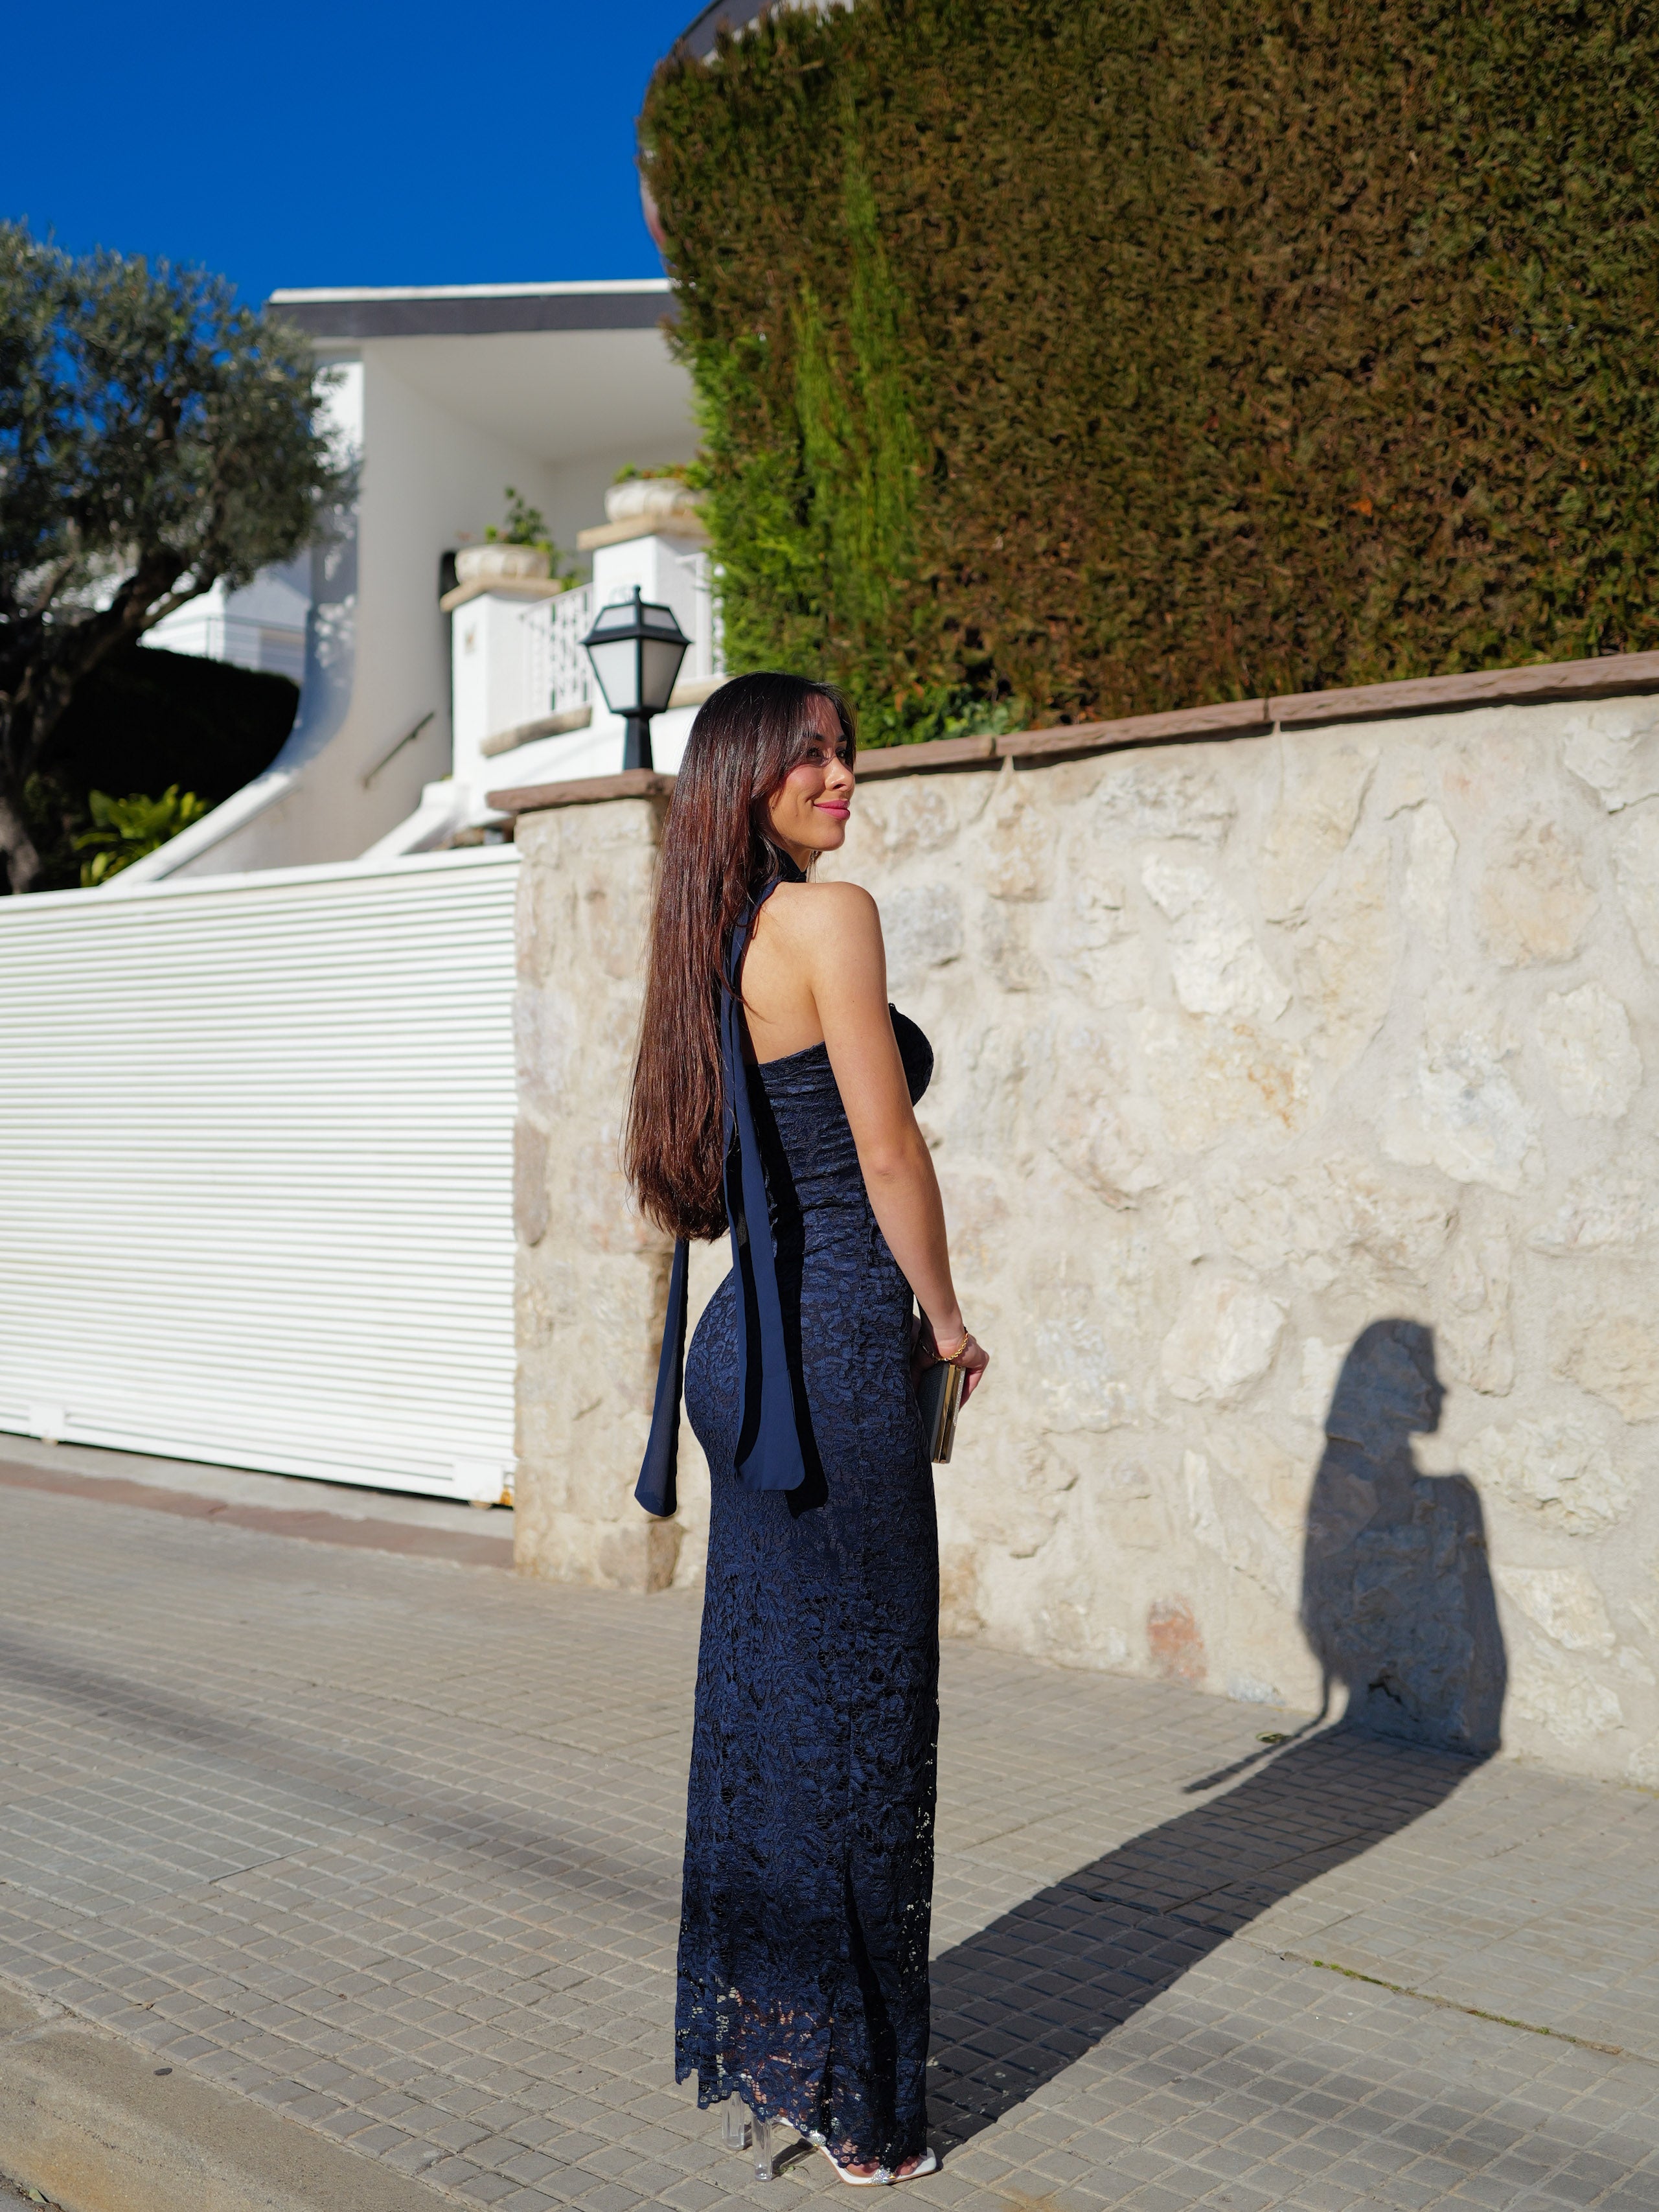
left=0, top=845, right=518, bottom=1500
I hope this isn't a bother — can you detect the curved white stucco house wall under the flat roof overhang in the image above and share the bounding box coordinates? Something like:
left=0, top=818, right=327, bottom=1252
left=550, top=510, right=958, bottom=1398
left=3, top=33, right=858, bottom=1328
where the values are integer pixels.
left=133, top=312, right=694, bottom=882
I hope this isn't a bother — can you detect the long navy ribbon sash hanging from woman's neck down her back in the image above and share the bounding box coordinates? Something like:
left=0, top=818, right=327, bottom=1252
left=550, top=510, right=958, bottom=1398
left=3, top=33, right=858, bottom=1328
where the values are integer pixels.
left=635, top=854, right=807, bottom=1517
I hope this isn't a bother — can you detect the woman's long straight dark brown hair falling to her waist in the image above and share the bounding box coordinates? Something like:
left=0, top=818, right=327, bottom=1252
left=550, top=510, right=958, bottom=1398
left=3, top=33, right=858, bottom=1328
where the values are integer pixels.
left=622, top=674, right=858, bottom=1236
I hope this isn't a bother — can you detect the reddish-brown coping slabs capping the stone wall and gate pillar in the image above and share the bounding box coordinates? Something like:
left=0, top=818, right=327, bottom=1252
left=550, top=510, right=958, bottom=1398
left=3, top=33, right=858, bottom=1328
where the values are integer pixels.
left=489, top=652, right=1659, bottom=814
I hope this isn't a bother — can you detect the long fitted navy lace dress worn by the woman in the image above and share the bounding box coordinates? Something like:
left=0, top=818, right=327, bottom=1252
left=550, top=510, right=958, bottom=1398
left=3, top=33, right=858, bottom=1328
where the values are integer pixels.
left=674, top=1013, right=938, bottom=2165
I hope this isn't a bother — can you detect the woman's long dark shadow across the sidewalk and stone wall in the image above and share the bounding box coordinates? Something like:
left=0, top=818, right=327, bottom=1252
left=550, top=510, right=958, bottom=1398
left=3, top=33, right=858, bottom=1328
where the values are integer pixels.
left=929, top=1320, right=1506, bottom=2148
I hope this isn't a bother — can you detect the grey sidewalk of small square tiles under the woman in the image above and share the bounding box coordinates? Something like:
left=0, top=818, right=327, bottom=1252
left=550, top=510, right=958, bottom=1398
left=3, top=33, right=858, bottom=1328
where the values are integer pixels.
left=0, top=1486, right=1659, bottom=2212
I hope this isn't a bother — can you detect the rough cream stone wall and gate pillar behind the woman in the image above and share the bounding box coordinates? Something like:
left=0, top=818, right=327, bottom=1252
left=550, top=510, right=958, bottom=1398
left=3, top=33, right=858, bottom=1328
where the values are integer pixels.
left=506, top=699, right=1659, bottom=1785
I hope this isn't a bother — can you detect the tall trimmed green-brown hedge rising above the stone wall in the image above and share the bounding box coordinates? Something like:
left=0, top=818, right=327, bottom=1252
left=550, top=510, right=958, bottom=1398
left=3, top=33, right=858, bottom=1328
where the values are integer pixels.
left=641, top=0, right=1659, bottom=739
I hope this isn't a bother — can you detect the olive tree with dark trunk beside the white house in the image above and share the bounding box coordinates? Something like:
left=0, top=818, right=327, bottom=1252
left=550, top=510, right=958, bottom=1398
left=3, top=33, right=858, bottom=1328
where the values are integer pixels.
left=0, top=224, right=350, bottom=892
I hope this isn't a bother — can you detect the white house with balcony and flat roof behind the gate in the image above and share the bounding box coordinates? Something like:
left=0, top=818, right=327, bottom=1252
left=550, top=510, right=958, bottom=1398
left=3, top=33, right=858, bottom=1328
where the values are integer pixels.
left=121, top=279, right=719, bottom=892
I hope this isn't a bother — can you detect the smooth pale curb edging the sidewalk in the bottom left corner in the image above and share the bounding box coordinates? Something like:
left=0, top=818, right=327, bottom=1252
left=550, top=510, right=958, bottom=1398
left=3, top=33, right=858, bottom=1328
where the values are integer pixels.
left=0, top=1987, right=447, bottom=2212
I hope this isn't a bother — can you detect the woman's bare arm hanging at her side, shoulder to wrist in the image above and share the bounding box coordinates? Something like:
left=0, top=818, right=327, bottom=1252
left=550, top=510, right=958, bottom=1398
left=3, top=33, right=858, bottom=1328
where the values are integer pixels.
left=788, top=882, right=987, bottom=1391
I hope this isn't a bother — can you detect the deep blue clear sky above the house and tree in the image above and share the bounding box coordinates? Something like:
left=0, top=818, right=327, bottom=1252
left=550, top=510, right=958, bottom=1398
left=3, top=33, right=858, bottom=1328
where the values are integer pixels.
left=0, top=0, right=699, bottom=305
